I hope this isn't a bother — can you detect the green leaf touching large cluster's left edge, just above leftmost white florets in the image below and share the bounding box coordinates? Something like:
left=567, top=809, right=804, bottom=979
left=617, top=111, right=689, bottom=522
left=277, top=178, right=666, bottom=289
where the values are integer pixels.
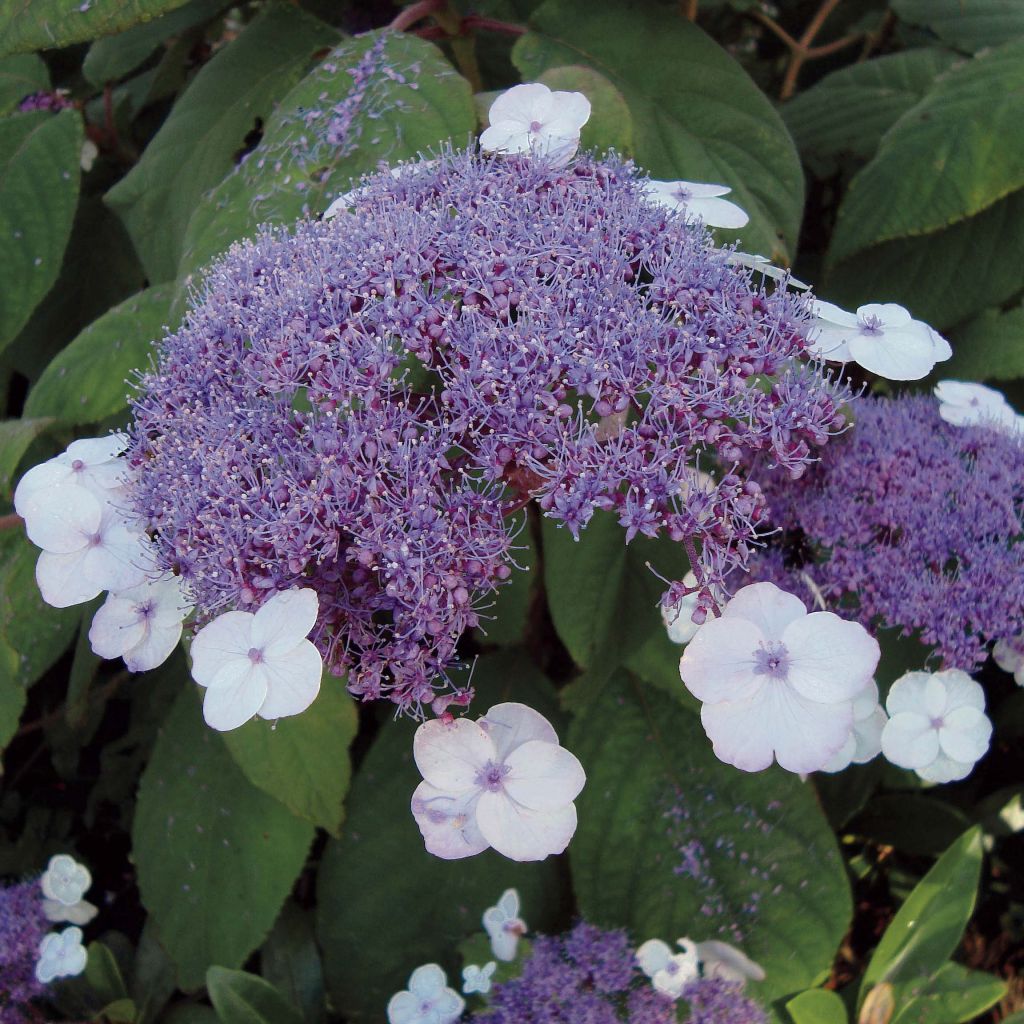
left=25, top=285, right=174, bottom=425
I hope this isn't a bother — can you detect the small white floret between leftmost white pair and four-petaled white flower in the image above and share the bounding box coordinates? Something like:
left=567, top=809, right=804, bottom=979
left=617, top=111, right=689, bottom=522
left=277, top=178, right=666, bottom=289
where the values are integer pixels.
left=89, top=577, right=191, bottom=672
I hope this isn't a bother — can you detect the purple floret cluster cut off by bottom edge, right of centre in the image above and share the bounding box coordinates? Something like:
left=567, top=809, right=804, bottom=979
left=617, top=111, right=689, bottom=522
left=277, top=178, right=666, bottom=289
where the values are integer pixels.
left=473, top=922, right=766, bottom=1024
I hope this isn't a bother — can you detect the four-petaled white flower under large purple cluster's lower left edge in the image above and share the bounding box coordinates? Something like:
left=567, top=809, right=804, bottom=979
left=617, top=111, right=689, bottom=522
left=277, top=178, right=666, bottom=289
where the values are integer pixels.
left=191, top=589, right=324, bottom=731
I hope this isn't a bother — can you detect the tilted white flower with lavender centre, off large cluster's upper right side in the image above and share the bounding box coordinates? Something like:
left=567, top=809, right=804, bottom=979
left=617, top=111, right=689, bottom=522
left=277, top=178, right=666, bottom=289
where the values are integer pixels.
left=808, top=300, right=953, bottom=381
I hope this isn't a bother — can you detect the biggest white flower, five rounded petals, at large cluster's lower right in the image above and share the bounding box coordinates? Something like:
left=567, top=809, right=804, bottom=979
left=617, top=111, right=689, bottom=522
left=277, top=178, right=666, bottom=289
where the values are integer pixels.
left=679, top=583, right=880, bottom=772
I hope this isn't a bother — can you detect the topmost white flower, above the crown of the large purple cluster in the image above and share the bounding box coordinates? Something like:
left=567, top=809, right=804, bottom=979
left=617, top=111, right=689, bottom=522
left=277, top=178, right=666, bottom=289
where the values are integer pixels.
left=480, top=82, right=590, bottom=167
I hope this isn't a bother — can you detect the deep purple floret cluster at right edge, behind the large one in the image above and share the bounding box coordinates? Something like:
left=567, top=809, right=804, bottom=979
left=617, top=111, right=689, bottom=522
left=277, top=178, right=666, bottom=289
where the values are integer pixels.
left=752, top=396, right=1024, bottom=672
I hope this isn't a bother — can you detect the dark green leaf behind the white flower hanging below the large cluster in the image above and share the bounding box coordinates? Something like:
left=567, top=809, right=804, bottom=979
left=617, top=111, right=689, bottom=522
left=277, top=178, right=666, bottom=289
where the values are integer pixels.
left=316, top=652, right=564, bottom=1022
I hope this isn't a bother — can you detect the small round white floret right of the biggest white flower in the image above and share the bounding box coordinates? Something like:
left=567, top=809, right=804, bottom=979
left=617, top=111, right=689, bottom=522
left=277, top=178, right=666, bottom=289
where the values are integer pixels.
left=882, top=669, right=992, bottom=782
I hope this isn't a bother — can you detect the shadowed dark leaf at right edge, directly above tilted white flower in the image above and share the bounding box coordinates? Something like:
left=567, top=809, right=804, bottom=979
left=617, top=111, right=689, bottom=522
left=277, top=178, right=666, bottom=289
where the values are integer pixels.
left=819, top=184, right=1024, bottom=327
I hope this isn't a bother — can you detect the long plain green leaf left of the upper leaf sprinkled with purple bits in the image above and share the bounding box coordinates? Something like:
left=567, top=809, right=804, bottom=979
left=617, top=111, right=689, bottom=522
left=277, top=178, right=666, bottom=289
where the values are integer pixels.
left=106, top=4, right=337, bottom=283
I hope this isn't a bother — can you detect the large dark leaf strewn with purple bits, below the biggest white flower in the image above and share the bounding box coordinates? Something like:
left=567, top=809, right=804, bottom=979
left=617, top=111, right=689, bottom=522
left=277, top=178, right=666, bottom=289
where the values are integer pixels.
left=567, top=674, right=851, bottom=998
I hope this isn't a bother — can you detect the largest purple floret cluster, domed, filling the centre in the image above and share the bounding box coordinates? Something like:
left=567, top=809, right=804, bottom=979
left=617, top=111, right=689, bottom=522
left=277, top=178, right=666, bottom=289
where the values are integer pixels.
left=129, top=152, right=847, bottom=714
